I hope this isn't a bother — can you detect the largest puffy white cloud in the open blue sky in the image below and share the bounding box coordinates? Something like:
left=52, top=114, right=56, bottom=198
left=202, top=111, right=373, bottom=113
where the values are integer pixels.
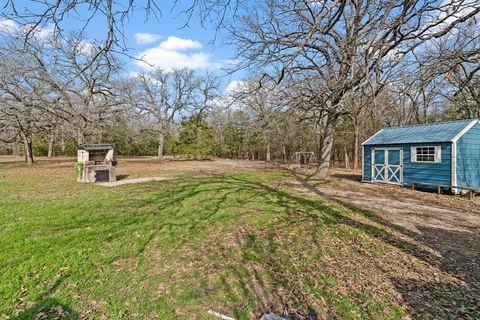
left=136, top=36, right=222, bottom=70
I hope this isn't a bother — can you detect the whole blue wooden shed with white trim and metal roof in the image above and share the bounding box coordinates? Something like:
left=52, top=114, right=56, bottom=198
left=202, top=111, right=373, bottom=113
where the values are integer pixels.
left=362, top=119, right=480, bottom=191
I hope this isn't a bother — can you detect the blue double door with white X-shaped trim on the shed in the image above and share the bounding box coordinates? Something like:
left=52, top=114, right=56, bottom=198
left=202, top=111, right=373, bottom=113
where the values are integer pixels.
left=372, top=148, right=403, bottom=184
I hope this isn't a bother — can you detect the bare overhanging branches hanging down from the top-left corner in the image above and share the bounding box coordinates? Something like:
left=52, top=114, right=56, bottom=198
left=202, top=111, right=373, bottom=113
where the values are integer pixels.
left=1, top=0, right=161, bottom=72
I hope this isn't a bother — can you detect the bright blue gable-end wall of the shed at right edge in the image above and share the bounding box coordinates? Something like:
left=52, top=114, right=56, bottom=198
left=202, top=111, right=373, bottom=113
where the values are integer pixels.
left=457, top=124, right=480, bottom=188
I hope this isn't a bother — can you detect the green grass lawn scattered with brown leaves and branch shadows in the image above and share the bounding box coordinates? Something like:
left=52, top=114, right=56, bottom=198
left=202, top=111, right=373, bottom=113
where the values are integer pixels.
left=0, top=159, right=476, bottom=319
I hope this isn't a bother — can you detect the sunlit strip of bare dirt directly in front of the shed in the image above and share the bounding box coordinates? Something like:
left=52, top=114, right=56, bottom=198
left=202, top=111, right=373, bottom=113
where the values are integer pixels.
left=296, top=170, right=480, bottom=234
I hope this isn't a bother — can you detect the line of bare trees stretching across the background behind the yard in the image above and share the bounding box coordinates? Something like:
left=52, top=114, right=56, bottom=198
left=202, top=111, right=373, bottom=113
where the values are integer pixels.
left=0, top=0, right=480, bottom=177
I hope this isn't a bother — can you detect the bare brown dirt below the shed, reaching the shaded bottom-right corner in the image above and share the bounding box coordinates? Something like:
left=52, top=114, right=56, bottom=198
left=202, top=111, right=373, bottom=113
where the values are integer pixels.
left=291, top=171, right=480, bottom=319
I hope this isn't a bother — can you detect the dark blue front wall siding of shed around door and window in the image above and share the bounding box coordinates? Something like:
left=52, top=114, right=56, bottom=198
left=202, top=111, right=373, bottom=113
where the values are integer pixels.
left=363, top=143, right=452, bottom=186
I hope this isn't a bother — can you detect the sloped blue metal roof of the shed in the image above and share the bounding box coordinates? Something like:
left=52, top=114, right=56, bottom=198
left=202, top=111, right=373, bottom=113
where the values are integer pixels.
left=363, top=119, right=478, bottom=145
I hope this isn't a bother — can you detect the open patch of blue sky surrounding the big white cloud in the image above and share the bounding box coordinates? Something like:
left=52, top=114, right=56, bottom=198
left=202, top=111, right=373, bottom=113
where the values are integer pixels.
left=120, top=1, right=233, bottom=71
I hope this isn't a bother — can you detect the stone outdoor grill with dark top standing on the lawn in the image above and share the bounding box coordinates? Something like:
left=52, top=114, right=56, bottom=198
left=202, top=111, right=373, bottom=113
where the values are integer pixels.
left=77, top=144, right=117, bottom=182
